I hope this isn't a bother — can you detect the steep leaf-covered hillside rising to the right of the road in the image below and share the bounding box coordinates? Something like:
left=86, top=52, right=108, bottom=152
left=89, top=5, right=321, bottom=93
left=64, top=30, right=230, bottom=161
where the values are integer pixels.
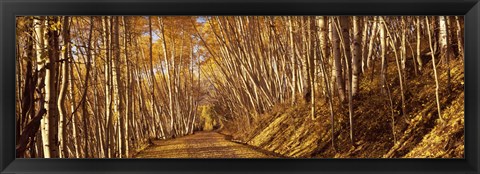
left=221, top=56, right=464, bottom=158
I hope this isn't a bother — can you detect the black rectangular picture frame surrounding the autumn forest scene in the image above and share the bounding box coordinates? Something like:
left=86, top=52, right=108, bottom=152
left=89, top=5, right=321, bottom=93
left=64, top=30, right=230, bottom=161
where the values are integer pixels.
left=0, top=0, right=480, bottom=174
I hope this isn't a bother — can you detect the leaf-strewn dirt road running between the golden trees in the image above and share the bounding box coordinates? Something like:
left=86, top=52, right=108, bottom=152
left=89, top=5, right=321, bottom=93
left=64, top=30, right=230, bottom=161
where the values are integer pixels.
left=135, top=132, right=274, bottom=158
